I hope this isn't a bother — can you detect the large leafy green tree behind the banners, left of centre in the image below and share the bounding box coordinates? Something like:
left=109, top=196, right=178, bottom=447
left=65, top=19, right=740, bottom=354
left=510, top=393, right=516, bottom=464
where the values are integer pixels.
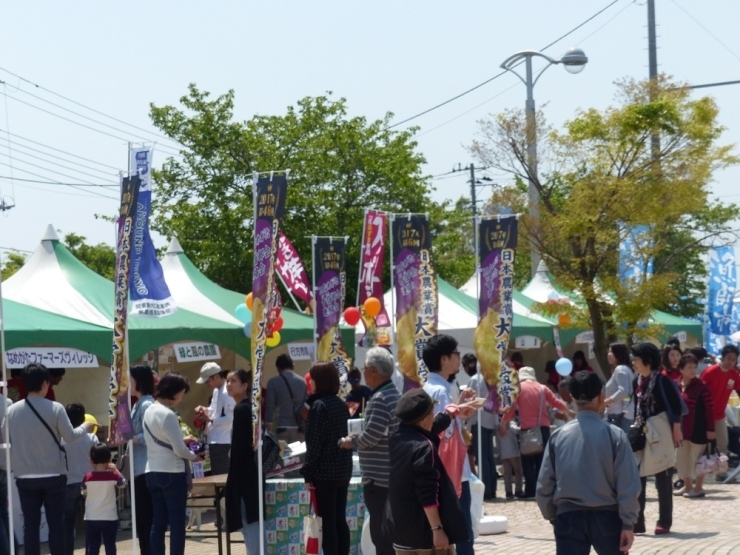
left=150, top=85, right=432, bottom=304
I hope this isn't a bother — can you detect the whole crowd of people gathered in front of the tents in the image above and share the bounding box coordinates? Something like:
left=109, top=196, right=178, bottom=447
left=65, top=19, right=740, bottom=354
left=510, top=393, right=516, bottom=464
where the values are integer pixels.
left=0, top=335, right=740, bottom=555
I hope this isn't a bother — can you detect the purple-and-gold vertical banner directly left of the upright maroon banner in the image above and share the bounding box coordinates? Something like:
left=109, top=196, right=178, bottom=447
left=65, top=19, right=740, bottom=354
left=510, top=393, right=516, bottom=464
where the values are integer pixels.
left=311, top=237, right=352, bottom=394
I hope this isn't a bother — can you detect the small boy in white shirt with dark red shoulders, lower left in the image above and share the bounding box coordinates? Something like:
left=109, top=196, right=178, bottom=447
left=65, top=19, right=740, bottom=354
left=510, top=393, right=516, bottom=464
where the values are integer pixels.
left=82, top=443, right=126, bottom=555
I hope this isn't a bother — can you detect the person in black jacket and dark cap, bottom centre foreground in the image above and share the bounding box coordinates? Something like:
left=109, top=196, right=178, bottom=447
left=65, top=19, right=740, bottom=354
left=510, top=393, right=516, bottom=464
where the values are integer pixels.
left=383, top=389, right=468, bottom=555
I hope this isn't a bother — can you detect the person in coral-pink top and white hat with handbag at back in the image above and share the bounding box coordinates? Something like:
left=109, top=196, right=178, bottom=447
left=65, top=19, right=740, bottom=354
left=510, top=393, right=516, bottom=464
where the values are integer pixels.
left=499, top=366, right=575, bottom=499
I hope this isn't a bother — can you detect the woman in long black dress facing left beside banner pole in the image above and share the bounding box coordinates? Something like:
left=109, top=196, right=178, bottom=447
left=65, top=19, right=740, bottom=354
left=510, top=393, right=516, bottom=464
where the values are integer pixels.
left=226, top=370, right=261, bottom=555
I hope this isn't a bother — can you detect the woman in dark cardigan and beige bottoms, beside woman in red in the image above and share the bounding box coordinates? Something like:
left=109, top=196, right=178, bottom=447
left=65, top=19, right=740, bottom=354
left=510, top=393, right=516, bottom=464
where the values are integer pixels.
left=674, top=354, right=714, bottom=498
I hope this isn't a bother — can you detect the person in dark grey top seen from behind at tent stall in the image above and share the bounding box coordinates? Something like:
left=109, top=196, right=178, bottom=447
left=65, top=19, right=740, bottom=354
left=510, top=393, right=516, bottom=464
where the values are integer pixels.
left=265, top=355, right=307, bottom=443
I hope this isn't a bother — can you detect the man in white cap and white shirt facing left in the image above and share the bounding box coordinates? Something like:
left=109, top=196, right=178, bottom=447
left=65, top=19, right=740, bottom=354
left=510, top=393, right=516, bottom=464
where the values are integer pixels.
left=195, top=362, right=236, bottom=476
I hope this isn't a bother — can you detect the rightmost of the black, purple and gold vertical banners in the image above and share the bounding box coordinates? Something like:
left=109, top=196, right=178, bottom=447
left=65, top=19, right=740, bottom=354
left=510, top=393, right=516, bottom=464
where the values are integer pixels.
left=473, top=216, right=519, bottom=412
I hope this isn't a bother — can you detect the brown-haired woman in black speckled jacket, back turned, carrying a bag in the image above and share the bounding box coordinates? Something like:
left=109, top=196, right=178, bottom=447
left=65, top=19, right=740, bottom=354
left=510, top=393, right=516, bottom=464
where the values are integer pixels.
left=301, top=362, right=352, bottom=555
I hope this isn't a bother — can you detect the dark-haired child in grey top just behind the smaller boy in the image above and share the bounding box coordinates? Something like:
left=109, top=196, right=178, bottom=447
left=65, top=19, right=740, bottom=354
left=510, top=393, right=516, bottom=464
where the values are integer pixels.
left=62, top=403, right=99, bottom=555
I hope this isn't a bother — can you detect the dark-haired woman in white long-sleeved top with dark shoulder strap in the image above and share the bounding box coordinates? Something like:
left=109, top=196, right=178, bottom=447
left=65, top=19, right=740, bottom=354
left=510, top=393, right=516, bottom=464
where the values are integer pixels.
left=144, top=373, right=200, bottom=555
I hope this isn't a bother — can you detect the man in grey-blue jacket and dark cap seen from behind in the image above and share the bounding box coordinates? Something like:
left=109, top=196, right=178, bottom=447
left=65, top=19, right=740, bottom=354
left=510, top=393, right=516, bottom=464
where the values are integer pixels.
left=536, top=370, right=641, bottom=555
